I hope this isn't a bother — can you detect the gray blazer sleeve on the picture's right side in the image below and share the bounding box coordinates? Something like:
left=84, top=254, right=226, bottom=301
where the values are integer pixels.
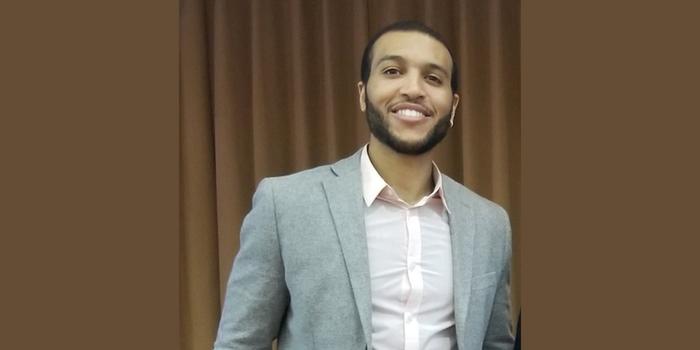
left=483, top=208, right=514, bottom=350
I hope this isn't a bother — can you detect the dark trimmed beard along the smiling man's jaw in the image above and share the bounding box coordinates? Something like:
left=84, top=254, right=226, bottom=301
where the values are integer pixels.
left=365, top=95, right=451, bottom=156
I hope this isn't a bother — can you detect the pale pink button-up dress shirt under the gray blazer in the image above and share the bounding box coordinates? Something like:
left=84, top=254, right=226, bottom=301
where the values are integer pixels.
left=360, top=146, right=457, bottom=350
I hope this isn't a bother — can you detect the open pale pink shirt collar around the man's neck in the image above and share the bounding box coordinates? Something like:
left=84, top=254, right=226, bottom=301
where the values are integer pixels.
left=360, top=145, right=450, bottom=213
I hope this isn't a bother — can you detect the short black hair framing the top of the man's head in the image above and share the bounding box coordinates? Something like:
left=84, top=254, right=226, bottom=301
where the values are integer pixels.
left=360, top=20, right=459, bottom=93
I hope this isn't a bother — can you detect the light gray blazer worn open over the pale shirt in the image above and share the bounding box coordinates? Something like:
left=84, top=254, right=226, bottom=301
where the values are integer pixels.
left=214, top=151, right=513, bottom=350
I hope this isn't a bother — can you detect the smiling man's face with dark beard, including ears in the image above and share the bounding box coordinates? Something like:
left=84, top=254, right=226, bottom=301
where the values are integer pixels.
left=358, top=31, right=459, bottom=155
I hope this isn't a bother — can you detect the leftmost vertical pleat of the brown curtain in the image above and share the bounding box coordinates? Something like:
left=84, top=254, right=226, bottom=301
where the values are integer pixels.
left=180, top=1, right=220, bottom=349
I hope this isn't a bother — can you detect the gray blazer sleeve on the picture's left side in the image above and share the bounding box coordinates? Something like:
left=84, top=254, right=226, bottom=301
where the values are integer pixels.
left=214, top=179, right=289, bottom=350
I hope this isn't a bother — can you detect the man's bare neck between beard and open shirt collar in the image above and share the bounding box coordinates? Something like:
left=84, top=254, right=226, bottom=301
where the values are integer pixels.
left=367, top=136, right=434, bottom=204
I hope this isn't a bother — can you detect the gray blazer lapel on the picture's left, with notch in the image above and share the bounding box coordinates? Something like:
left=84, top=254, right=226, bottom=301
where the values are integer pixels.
left=323, top=152, right=372, bottom=348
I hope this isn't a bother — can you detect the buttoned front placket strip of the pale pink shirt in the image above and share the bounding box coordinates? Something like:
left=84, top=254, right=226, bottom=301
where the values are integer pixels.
left=404, top=208, right=423, bottom=350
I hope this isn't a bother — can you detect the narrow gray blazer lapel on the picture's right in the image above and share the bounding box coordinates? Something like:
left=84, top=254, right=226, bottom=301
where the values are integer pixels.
left=443, top=177, right=476, bottom=349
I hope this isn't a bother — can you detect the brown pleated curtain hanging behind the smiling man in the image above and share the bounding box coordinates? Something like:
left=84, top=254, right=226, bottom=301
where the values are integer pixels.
left=180, top=0, right=520, bottom=350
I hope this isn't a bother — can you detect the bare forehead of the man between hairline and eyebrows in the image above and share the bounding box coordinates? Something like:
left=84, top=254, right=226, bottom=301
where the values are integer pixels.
left=371, top=31, right=452, bottom=71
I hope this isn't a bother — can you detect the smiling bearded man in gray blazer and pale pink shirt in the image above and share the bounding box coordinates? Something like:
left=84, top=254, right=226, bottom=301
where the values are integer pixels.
left=214, top=22, right=513, bottom=350
